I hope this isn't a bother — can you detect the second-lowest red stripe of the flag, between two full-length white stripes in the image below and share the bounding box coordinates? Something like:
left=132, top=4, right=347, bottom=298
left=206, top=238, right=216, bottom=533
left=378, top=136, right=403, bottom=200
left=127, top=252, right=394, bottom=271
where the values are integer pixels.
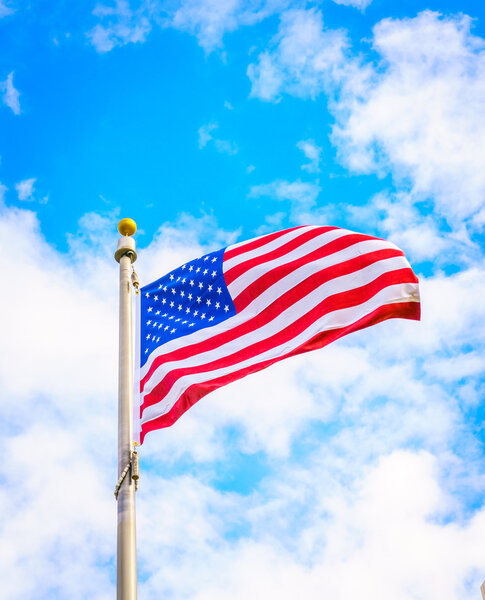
left=140, top=268, right=415, bottom=414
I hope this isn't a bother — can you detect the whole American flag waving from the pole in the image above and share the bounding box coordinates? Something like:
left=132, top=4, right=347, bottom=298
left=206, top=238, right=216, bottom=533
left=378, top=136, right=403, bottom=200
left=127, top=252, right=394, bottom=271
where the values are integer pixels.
left=134, top=226, right=420, bottom=443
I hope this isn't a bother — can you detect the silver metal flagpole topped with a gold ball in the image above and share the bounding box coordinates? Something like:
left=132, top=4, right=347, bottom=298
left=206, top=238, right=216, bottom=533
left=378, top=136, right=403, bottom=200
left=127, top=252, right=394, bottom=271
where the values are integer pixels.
left=115, top=219, right=137, bottom=600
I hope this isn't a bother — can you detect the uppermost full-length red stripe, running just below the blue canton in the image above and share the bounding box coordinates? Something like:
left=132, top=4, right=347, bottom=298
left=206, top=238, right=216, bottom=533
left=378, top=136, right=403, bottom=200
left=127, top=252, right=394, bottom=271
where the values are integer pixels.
left=140, top=249, right=408, bottom=392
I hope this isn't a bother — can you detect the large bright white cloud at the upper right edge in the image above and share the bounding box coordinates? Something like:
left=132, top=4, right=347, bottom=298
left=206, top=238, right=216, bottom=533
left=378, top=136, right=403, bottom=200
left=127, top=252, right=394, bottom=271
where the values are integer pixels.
left=333, top=11, right=485, bottom=228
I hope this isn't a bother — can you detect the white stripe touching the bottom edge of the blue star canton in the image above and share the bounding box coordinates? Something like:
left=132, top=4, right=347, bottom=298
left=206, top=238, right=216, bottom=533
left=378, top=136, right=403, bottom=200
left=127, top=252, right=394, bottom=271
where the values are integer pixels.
left=140, top=240, right=400, bottom=379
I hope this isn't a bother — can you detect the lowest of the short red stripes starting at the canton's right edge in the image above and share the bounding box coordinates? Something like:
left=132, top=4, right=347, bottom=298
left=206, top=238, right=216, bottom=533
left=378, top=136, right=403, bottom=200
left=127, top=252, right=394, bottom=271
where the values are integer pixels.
left=234, top=233, right=404, bottom=313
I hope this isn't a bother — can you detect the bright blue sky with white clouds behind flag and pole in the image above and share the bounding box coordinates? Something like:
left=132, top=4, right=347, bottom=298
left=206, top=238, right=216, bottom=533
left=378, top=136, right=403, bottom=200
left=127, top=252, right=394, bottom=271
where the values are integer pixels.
left=0, top=0, right=485, bottom=600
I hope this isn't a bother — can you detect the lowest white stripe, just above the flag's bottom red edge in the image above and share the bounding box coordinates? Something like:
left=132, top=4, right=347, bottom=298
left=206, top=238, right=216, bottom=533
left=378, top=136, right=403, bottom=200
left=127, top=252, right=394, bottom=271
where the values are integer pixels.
left=141, top=283, right=419, bottom=423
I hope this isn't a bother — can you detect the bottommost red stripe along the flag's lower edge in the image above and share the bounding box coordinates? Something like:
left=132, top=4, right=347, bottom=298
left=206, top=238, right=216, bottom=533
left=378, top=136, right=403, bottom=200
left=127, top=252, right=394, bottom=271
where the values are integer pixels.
left=140, top=302, right=421, bottom=444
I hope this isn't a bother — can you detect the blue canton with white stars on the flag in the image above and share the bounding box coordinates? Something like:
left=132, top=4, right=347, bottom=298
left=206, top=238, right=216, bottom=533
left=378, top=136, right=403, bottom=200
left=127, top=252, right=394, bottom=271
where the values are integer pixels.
left=140, top=248, right=236, bottom=366
